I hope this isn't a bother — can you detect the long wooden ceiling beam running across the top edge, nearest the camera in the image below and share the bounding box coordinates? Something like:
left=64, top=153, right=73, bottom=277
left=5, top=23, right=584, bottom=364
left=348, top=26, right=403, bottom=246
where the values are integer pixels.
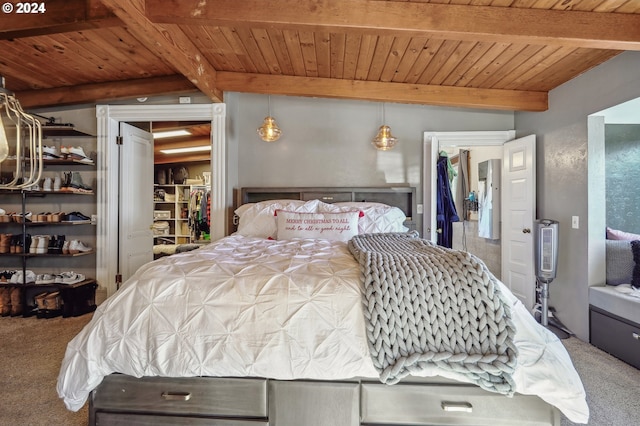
left=146, top=0, right=640, bottom=50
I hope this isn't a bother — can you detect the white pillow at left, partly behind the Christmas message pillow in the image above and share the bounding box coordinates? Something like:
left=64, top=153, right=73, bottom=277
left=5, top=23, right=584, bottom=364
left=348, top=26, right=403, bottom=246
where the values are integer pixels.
left=235, top=200, right=318, bottom=238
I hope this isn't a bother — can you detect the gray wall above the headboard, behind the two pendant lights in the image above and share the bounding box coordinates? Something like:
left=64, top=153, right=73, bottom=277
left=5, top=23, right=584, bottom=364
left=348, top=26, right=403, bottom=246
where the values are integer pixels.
left=225, top=93, right=514, bottom=236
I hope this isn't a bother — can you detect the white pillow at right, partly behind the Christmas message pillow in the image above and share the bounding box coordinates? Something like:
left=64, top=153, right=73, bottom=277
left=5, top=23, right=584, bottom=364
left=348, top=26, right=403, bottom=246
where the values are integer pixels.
left=318, top=201, right=409, bottom=234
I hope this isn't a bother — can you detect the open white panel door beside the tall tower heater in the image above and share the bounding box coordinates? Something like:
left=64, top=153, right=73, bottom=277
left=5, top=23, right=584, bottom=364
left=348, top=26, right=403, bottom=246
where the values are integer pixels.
left=501, top=135, right=536, bottom=309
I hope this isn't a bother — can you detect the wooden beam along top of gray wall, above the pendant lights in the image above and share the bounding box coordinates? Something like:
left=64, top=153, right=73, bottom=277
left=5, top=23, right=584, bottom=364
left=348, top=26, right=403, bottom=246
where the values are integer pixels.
left=218, top=72, right=548, bottom=111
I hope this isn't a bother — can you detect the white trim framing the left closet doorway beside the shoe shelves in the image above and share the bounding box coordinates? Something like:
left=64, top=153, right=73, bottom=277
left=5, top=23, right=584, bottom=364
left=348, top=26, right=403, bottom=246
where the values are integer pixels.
left=96, top=103, right=227, bottom=296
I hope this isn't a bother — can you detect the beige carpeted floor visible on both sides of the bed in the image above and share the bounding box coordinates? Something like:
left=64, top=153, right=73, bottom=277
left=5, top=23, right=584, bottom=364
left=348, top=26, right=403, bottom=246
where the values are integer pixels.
left=0, top=314, right=640, bottom=426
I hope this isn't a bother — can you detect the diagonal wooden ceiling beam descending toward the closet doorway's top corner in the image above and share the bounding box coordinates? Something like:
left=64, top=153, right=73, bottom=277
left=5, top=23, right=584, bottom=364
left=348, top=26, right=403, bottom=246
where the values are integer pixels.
left=101, top=0, right=223, bottom=102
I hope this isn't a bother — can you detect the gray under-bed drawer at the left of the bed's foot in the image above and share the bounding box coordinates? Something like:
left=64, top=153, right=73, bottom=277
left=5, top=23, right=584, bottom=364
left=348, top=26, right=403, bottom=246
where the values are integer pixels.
left=90, top=374, right=267, bottom=419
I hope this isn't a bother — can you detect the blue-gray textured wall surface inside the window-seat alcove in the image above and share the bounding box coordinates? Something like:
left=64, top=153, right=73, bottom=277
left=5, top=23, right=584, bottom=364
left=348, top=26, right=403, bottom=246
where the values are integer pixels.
left=605, top=125, right=640, bottom=234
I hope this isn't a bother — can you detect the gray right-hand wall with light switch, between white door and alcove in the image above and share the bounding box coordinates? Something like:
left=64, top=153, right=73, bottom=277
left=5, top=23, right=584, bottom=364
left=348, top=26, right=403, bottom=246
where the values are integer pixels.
left=515, top=52, right=640, bottom=341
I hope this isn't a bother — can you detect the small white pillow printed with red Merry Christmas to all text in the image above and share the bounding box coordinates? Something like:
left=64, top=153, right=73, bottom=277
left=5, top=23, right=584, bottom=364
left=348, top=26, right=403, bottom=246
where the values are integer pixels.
left=277, top=210, right=360, bottom=242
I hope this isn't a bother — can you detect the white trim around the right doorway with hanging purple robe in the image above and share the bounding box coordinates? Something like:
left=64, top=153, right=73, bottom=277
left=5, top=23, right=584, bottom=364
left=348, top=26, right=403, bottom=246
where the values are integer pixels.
left=422, top=130, right=516, bottom=243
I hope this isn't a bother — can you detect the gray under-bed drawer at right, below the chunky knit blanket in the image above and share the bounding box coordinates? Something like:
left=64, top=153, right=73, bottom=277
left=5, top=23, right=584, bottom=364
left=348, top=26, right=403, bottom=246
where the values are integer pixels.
left=361, top=383, right=560, bottom=426
